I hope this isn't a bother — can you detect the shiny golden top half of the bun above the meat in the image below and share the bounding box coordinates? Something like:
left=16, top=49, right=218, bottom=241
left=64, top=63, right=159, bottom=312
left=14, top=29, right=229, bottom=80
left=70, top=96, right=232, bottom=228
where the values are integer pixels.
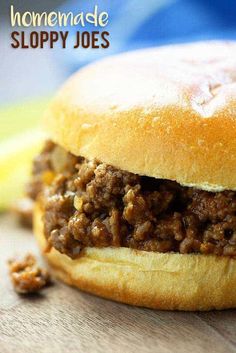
left=45, top=42, right=236, bottom=191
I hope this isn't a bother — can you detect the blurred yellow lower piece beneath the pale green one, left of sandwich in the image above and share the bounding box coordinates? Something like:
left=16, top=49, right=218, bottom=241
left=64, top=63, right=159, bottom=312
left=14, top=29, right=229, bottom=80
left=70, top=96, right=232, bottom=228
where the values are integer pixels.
left=0, top=129, right=45, bottom=211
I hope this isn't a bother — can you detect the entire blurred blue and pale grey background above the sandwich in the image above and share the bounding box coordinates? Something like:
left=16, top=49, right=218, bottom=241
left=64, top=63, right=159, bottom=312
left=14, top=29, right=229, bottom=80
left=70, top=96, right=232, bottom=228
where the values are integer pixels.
left=0, top=0, right=236, bottom=104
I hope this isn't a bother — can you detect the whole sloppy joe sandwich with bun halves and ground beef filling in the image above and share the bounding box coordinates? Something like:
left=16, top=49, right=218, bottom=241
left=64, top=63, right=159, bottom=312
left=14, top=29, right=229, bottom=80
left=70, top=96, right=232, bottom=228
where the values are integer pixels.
left=28, top=42, right=236, bottom=310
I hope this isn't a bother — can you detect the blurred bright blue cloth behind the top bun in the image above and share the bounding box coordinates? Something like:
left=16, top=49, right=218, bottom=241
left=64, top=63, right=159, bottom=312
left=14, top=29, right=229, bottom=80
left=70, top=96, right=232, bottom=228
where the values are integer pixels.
left=60, top=0, right=236, bottom=71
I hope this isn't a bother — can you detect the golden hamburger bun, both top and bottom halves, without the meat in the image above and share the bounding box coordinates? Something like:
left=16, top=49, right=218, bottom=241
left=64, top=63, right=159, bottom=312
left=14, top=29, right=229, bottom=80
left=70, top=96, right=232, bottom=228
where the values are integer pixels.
left=34, top=42, right=236, bottom=310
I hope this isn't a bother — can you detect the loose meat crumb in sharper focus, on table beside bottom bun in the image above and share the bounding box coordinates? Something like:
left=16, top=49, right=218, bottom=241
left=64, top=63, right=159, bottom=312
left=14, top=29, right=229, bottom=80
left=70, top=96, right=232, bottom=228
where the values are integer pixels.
left=8, top=254, right=50, bottom=294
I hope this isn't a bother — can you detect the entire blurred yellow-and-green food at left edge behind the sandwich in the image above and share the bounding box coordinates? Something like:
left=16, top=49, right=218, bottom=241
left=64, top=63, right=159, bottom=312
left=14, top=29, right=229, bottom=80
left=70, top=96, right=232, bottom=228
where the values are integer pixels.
left=0, top=98, right=49, bottom=211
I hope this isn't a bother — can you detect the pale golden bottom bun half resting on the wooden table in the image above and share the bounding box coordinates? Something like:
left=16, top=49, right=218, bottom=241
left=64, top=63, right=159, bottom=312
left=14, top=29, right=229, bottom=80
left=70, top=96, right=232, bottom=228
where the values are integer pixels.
left=34, top=204, right=236, bottom=310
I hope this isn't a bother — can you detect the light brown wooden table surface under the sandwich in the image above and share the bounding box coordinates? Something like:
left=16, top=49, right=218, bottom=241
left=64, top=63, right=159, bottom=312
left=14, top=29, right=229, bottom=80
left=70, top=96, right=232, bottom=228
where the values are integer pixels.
left=0, top=215, right=236, bottom=353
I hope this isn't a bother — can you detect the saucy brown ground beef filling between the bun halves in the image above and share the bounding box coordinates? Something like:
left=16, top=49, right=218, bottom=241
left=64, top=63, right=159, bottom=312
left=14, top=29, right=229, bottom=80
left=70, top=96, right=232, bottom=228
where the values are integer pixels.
left=28, top=142, right=236, bottom=258
